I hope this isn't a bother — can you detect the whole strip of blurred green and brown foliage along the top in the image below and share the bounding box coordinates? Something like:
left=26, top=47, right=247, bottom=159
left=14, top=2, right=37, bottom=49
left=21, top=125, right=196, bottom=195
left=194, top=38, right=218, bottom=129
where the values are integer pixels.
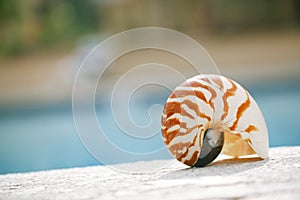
left=0, top=0, right=300, bottom=55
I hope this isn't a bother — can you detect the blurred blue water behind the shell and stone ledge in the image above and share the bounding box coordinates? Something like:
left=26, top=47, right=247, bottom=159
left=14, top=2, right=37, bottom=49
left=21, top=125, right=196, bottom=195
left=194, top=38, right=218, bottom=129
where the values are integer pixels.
left=0, top=79, right=300, bottom=174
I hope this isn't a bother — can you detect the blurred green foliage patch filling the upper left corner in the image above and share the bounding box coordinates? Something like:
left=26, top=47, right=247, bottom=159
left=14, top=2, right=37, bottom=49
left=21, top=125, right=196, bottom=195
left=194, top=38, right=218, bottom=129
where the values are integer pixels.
left=0, top=0, right=100, bottom=54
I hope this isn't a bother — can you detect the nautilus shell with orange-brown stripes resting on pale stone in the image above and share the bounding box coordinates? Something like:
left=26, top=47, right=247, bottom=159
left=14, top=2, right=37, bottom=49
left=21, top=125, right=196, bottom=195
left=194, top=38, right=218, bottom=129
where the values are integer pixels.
left=161, top=74, right=269, bottom=167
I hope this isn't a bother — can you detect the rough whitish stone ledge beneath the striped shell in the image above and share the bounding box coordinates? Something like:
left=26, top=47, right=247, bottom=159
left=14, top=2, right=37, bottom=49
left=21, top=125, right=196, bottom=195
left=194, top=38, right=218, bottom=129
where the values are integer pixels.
left=0, top=147, right=300, bottom=200
